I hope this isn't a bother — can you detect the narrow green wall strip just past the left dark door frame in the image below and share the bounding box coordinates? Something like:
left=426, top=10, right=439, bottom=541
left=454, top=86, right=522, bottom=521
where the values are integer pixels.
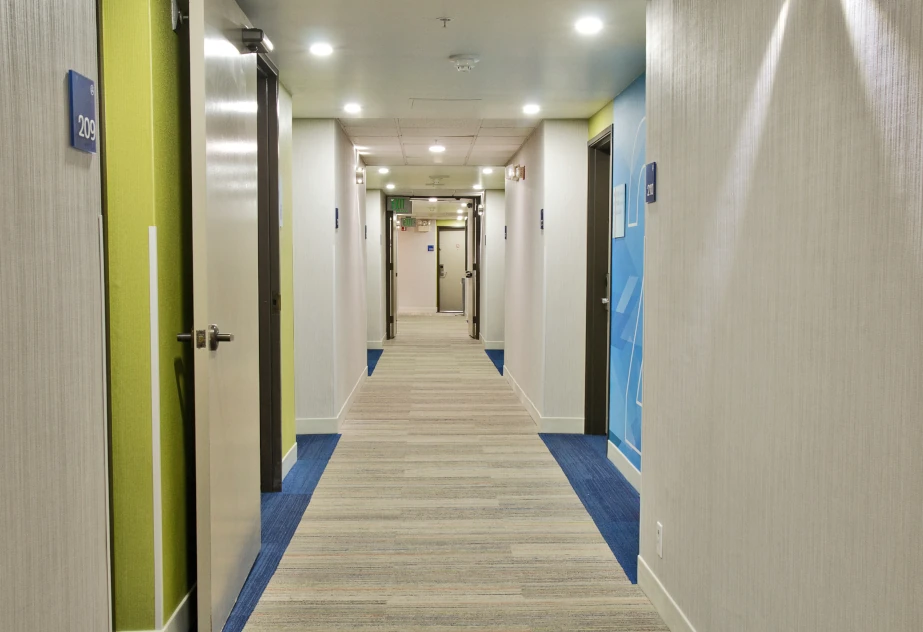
left=279, top=86, right=295, bottom=456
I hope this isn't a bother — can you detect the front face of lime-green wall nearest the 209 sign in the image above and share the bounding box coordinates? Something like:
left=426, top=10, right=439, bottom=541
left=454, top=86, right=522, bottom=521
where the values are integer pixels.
left=100, top=0, right=154, bottom=630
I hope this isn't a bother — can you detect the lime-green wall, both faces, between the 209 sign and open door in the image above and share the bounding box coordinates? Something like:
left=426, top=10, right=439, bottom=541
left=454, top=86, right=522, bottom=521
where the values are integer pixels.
left=100, top=0, right=195, bottom=630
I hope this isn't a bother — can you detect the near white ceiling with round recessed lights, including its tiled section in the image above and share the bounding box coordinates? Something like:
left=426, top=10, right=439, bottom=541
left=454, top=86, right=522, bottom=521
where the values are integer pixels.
left=239, top=0, right=646, bottom=166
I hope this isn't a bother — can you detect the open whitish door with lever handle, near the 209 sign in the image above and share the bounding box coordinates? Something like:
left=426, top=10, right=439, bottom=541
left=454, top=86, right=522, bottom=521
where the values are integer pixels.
left=189, top=0, right=260, bottom=632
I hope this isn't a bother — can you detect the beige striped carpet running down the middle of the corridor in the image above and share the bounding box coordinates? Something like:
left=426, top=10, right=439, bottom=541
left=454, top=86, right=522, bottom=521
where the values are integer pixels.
left=246, top=316, right=667, bottom=631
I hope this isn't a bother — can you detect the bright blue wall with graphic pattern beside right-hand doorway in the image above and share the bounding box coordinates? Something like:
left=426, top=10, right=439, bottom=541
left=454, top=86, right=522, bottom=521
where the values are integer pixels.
left=609, top=75, right=647, bottom=470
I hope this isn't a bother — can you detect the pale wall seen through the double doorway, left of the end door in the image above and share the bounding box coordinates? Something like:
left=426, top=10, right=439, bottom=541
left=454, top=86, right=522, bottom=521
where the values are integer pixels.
left=395, top=228, right=436, bottom=314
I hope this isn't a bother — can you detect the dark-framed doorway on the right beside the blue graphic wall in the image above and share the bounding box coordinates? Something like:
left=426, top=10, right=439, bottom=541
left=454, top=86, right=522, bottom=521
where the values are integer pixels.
left=584, top=127, right=612, bottom=435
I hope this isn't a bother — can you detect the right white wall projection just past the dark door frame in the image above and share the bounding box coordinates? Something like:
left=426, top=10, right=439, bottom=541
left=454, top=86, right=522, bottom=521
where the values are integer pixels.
left=505, top=121, right=588, bottom=433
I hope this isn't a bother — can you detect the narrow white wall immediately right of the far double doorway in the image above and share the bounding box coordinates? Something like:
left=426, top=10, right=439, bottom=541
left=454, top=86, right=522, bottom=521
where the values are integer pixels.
left=481, top=190, right=506, bottom=349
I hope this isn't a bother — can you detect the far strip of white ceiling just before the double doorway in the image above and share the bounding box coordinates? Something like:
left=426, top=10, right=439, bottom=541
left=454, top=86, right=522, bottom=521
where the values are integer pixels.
left=366, top=165, right=506, bottom=198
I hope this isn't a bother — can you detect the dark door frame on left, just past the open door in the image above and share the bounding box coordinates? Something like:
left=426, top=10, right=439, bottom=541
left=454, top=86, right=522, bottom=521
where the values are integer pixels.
left=257, top=55, right=283, bottom=492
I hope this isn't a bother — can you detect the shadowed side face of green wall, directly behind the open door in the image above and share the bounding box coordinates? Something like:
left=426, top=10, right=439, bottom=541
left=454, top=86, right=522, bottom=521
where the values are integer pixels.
left=151, top=0, right=196, bottom=621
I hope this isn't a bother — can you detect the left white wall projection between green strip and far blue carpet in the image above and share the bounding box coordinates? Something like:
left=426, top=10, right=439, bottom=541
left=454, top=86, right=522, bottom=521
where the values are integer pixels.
left=292, top=119, right=368, bottom=434
